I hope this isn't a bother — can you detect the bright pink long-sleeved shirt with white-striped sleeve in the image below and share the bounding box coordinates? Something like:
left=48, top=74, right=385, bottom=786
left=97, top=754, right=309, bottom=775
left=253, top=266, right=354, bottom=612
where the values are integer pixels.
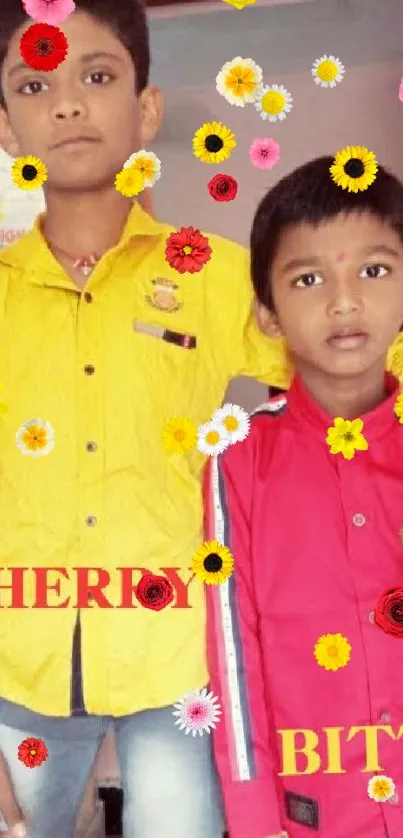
left=206, top=375, right=403, bottom=838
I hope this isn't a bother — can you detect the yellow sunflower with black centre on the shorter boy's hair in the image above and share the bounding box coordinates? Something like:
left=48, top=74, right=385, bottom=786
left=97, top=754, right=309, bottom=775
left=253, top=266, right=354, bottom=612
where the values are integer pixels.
left=330, top=145, right=378, bottom=192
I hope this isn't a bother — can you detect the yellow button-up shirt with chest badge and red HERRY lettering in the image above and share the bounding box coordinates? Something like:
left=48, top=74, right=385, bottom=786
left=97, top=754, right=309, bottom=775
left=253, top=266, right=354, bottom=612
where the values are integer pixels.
left=0, top=204, right=402, bottom=716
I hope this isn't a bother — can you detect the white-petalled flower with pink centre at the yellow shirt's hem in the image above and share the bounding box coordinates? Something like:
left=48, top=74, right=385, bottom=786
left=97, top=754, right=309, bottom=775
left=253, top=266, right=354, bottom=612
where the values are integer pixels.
left=172, top=687, right=222, bottom=736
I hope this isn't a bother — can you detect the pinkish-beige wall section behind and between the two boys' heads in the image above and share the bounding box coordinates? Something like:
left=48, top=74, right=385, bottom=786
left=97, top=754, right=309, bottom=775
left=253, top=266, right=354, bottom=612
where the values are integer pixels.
left=153, top=60, right=403, bottom=244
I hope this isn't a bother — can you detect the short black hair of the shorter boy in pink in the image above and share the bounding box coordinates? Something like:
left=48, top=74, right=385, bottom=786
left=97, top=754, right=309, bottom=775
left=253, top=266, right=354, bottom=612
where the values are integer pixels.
left=250, top=157, right=403, bottom=311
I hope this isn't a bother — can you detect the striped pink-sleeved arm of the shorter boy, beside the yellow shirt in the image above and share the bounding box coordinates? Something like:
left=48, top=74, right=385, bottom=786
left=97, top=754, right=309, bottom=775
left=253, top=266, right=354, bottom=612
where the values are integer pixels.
left=205, top=438, right=282, bottom=838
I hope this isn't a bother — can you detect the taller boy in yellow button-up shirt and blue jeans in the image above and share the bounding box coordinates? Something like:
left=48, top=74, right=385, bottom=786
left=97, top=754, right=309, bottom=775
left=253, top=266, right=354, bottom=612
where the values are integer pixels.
left=0, top=0, right=289, bottom=838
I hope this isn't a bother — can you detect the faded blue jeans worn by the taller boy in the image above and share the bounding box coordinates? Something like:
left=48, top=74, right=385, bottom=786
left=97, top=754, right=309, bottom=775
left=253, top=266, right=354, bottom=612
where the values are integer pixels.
left=0, top=707, right=224, bottom=838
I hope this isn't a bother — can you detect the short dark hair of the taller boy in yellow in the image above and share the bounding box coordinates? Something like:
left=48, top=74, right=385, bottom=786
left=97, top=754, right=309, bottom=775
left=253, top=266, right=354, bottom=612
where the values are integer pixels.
left=0, top=0, right=150, bottom=108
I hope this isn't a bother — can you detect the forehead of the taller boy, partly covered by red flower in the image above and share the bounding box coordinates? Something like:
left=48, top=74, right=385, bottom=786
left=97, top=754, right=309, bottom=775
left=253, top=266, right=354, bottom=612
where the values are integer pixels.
left=5, top=9, right=130, bottom=73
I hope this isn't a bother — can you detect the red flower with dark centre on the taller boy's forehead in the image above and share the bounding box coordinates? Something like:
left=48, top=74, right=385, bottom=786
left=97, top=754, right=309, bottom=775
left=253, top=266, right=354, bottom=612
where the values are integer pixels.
left=20, top=23, right=69, bottom=72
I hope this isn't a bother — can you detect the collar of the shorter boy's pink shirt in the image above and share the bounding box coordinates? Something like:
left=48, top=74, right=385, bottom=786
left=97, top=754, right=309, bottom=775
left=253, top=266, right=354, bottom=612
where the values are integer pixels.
left=287, top=372, right=400, bottom=443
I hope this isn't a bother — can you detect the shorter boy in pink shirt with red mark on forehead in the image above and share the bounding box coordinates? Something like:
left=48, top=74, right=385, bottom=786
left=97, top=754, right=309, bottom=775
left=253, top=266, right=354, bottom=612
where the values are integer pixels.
left=206, top=157, right=403, bottom=838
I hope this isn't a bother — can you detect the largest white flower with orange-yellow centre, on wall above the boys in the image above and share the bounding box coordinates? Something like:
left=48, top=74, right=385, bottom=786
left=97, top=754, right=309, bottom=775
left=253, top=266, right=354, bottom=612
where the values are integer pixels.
left=216, top=56, right=263, bottom=108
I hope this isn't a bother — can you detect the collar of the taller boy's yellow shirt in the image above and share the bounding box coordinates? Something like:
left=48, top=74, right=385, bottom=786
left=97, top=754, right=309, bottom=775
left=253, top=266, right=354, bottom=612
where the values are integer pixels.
left=0, top=201, right=167, bottom=287
